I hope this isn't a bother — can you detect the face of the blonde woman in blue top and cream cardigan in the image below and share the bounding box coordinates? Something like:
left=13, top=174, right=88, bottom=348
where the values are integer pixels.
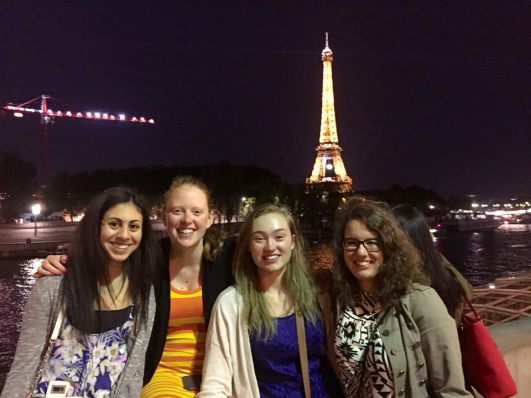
left=249, top=213, right=295, bottom=275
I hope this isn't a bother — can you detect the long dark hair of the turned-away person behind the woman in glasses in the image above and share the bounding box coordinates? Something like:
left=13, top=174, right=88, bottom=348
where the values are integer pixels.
left=392, top=205, right=473, bottom=323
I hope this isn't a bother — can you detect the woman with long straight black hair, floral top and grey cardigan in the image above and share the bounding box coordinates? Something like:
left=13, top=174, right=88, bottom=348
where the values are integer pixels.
left=3, top=187, right=160, bottom=397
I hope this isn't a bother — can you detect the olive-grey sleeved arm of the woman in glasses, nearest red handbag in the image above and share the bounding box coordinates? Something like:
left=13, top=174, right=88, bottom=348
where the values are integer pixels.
left=411, top=288, right=472, bottom=397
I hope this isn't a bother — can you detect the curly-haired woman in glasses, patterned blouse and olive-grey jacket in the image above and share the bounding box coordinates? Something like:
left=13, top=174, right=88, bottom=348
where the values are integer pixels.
left=329, top=198, right=471, bottom=398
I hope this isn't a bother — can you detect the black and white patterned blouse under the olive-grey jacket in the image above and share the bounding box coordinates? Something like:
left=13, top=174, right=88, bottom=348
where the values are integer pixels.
left=335, top=294, right=395, bottom=398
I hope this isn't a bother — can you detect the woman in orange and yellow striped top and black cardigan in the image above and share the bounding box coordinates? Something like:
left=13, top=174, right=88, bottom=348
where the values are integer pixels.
left=38, top=175, right=234, bottom=398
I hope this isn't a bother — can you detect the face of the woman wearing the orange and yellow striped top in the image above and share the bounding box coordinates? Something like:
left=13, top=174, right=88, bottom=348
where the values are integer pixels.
left=166, top=185, right=213, bottom=248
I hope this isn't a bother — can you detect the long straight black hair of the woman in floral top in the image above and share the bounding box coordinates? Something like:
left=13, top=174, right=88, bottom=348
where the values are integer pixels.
left=61, top=187, right=161, bottom=333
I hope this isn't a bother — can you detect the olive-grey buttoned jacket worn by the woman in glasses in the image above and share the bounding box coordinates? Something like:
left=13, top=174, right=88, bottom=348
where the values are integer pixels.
left=324, top=283, right=473, bottom=398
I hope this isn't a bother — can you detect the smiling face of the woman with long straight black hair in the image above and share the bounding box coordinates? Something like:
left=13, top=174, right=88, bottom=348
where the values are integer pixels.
left=100, top=202, right=142, bottom=265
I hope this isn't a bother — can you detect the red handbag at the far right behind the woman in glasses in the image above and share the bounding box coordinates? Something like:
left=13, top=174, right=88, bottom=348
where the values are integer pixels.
left=459, top=296, right=516, bottom=398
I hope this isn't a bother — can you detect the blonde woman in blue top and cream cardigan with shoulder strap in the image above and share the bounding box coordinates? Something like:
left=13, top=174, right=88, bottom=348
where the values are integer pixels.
left=198, top=204, right=336, bottom=398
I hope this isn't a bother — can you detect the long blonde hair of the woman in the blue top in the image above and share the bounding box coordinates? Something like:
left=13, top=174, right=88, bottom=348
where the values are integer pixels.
left=233, top=204, right=319, bottom=340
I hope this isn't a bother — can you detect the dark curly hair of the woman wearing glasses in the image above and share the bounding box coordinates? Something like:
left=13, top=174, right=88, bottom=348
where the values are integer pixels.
left=333, top=196, right=428, bottom=309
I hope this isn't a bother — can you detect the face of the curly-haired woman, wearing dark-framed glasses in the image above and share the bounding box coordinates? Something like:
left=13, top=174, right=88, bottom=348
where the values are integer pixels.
left=343, top=220, right=384, bottom=292
